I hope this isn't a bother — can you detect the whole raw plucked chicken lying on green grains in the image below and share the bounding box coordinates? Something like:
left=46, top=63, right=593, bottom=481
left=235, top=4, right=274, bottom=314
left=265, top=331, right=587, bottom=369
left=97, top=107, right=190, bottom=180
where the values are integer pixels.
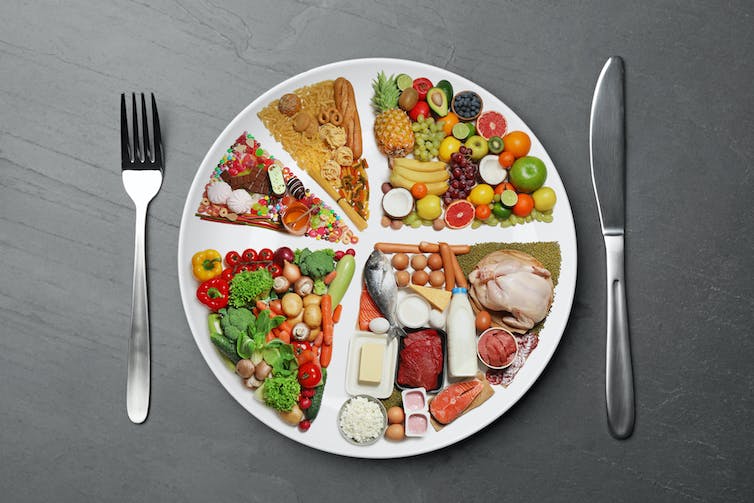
left=469, top=250, right=553, bottom=333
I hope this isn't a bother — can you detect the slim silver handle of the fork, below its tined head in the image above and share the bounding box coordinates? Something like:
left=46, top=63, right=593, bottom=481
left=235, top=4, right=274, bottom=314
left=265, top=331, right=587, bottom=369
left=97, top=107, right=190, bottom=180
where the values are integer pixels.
left=126, top=204, right=150, bottom=423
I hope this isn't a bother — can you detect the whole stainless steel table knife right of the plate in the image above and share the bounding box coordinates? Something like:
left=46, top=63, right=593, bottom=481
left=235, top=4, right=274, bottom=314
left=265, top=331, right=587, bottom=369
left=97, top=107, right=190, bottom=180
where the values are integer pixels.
left=589, top=56, right=636, bottom=439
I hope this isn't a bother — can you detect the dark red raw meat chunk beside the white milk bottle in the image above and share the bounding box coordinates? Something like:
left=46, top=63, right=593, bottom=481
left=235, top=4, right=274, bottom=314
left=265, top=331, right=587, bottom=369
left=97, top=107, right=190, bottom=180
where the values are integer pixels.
left=397, top=329, right=443, bottom=390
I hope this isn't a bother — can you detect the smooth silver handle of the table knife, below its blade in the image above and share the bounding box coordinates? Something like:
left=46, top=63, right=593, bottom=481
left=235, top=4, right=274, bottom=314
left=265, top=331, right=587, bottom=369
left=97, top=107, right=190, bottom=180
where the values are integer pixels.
left=605, top=234, right=636, bottom=439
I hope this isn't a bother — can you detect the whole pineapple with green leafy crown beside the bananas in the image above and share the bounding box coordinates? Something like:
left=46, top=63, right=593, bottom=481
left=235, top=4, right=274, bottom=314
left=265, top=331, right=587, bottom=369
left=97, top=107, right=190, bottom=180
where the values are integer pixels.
left=372, top=72, right=414, bottom=157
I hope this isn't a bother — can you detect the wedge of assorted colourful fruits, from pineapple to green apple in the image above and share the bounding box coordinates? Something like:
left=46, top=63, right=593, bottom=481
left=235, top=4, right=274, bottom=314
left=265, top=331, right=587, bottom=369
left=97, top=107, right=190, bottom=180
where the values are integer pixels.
left=372, top=72, right=556, bottom=230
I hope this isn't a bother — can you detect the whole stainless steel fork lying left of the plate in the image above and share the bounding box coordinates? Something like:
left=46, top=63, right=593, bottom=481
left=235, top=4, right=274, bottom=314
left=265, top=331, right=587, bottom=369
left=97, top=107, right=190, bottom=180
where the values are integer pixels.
left=120, top=93, right=163, bottom=423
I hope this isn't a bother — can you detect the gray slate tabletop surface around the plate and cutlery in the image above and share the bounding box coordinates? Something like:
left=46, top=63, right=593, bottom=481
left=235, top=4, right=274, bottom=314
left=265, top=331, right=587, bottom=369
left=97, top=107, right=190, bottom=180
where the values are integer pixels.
left=0, top=0, right=754, bottom=502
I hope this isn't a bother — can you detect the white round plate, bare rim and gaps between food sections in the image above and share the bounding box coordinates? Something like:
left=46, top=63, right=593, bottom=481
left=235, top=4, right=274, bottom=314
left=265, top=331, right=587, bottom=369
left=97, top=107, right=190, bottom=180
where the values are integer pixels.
left=178, top=59, right=576, bottom=458
